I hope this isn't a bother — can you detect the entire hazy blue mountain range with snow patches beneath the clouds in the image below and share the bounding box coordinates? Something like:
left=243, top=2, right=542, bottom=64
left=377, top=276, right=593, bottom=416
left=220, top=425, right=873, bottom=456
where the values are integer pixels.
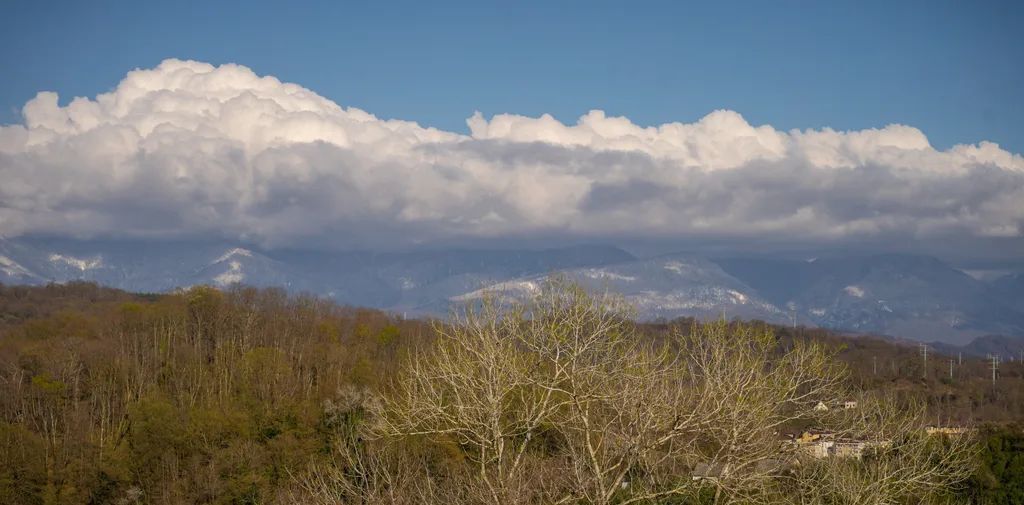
left=0, top=240, right=1024, bottom=344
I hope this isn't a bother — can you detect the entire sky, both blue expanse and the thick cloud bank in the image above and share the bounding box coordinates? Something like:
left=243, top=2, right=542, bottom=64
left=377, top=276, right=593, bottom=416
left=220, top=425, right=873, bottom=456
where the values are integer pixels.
left=0, top=1, right=1024, bottom=261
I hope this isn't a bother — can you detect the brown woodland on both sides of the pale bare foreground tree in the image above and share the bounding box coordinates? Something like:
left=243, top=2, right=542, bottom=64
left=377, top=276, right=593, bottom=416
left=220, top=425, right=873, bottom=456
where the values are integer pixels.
left=0, top=283, right=1024, bottom=504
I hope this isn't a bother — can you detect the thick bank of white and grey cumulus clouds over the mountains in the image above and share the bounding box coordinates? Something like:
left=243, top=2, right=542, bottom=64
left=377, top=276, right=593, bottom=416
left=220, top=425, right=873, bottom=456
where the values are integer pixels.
left=0, top=59, right=1024, bottom=254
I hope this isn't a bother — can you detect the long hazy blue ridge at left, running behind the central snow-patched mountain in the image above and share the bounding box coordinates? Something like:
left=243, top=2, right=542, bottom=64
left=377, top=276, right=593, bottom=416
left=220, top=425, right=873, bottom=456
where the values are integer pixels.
left=0, top=239, right=636, bottom=313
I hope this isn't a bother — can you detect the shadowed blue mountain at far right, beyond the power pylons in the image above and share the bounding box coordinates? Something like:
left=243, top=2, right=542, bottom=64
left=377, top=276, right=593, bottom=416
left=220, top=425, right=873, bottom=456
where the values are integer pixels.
left=718, top=255, right=1024, bottom=343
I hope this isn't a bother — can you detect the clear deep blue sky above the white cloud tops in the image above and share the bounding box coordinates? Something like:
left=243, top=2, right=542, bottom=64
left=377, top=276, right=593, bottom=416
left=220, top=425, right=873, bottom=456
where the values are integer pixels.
left=0, top=1, right=1024, bottom=153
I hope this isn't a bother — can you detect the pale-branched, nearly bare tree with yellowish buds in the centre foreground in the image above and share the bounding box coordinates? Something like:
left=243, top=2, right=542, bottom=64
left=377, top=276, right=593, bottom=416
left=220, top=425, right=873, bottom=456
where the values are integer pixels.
left=316, top=280, right=970, bottom=505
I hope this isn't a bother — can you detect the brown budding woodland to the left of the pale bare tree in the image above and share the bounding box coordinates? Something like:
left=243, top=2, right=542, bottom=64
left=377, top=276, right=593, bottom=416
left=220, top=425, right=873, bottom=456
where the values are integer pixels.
left=0, top=283, right=426, bottom=504
